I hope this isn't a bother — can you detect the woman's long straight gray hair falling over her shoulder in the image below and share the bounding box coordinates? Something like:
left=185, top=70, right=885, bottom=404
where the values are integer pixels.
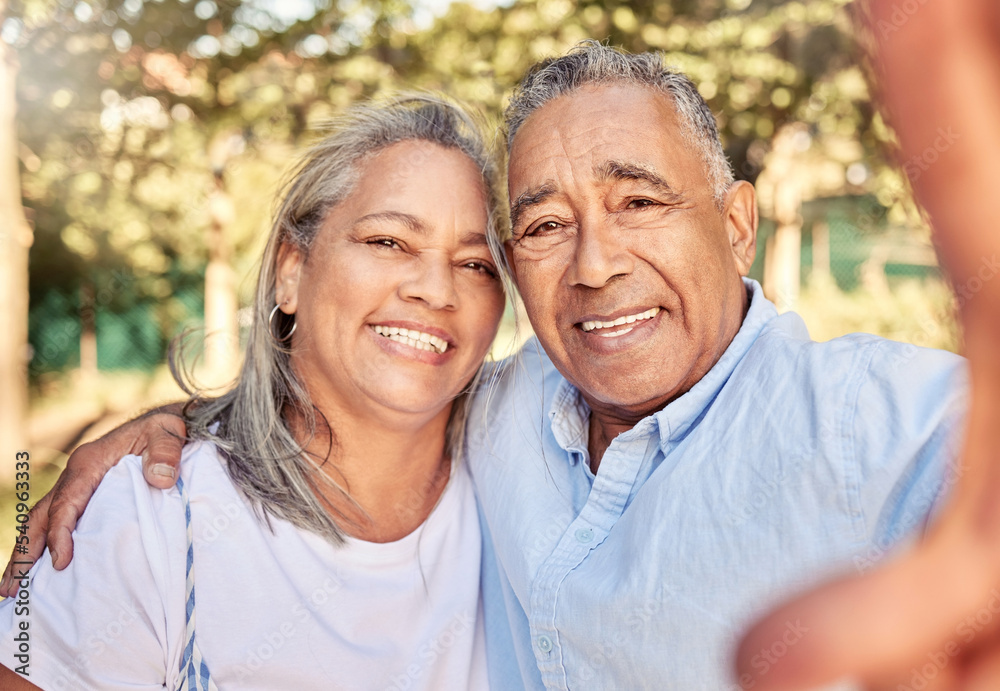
left=170, top=94, right=506, bottom=543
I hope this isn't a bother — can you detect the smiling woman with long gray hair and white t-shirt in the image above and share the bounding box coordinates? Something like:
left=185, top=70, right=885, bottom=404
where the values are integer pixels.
left=0, top=96, right=504, bottom=689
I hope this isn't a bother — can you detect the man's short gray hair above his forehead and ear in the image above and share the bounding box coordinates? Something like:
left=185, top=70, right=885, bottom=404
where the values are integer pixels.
left=504, top=40, right=734, bottom=208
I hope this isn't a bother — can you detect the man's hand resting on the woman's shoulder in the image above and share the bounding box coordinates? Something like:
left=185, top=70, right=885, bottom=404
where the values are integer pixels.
left=0, top=403, right=187, bottom=596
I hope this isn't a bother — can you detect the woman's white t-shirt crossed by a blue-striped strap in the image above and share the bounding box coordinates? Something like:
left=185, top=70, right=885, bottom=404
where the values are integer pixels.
left=0, top=442, right=487, bottom=691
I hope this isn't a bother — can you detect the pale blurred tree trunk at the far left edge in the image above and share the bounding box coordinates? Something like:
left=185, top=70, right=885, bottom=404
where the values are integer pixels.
left=0, top=20, right=33, bottom=482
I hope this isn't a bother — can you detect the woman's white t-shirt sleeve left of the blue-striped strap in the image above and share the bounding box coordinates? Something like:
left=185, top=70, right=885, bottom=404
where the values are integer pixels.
left=0, top=456, right=186, bottom=691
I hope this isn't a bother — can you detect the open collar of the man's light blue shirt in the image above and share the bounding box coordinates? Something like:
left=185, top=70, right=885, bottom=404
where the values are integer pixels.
left=549, top=278, right=778, bottom=465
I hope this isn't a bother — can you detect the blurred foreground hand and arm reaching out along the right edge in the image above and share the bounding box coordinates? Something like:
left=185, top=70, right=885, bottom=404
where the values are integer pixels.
left=737, top=0, right=1000, bottom=691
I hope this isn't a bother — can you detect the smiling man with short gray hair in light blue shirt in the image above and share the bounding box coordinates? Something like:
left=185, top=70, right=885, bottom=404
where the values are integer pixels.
left=11, top=43, right=965, bottom=690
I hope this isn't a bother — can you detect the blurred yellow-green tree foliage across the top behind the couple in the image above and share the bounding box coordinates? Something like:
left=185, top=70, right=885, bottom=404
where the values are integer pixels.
left=3, top=0, right=940, bottom=378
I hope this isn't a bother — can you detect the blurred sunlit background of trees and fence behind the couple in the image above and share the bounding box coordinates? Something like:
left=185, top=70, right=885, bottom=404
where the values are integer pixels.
left=0, top=0, right=960, bottom=549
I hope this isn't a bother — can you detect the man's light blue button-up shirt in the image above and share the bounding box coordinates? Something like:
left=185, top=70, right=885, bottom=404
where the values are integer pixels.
left=467, top=281, right=967, bottom=691
